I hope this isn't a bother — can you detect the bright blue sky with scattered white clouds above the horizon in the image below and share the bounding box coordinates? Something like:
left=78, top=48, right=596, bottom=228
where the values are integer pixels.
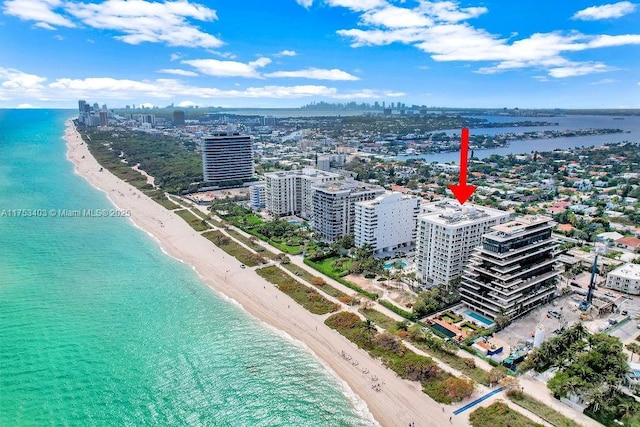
left=0, top=0, right=640, bottom=108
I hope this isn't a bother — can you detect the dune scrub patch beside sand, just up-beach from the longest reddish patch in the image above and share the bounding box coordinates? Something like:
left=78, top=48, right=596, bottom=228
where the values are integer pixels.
left=256, top=266, right=339, bottom=314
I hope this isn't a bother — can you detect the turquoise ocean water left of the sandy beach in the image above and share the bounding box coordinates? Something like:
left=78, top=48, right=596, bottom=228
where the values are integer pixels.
left=0, top=110, right=374, bottom=426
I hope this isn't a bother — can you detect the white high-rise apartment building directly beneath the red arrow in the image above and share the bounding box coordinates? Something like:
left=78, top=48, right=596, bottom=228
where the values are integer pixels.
left=415, top=199, right=509, bottom=288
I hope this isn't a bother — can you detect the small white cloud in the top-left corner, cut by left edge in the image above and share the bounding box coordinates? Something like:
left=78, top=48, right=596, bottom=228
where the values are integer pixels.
left=2, top=0, right=76, bottom=29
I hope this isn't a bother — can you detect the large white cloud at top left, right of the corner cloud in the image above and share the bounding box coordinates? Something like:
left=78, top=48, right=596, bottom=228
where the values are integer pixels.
left=66, top=0, right=223, bottom=48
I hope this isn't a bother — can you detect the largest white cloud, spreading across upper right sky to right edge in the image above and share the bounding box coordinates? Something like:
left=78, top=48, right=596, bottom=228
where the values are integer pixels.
left=325, top=0, right=640, bottom=78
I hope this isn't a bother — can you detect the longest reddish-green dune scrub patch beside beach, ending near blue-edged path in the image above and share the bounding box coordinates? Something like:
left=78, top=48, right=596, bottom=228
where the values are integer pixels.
left=325, top=311, right=473, bottom=404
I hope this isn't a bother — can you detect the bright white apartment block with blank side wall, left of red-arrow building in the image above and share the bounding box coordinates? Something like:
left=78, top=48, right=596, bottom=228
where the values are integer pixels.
left=353, top=192, right=420, bottom=254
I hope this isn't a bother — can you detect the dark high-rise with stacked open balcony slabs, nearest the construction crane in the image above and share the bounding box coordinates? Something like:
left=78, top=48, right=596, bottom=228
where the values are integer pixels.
left=460, top=215, right=560, bottom=320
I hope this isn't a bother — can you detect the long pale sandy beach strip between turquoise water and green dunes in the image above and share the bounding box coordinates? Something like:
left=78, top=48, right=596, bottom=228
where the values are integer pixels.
left=64, top=121, right=460, bottom=426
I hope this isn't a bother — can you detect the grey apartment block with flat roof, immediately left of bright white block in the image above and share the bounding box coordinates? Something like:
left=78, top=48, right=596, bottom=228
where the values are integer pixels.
left=311, top=179, right=384, bottom=242
